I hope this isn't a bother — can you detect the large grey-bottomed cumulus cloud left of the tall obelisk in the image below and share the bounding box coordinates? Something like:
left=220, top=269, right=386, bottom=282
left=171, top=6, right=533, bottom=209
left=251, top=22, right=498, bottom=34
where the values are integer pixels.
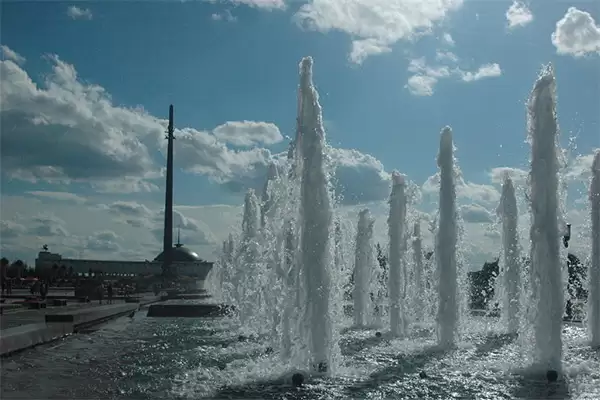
left=0, top=56, right=164, bottom=189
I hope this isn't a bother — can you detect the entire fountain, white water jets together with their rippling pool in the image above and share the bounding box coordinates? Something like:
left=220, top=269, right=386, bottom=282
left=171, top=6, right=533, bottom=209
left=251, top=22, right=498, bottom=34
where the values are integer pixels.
left=14, top=59, right=600, bottom=400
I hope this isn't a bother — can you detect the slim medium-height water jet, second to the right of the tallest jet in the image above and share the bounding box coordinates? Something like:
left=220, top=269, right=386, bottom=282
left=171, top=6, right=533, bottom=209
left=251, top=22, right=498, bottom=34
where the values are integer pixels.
left=388, top=171, right=406, bottom=336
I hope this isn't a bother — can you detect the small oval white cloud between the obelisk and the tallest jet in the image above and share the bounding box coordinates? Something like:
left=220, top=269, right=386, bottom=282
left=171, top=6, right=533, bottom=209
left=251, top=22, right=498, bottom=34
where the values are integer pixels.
left=213, top=121, right=283, bottom=147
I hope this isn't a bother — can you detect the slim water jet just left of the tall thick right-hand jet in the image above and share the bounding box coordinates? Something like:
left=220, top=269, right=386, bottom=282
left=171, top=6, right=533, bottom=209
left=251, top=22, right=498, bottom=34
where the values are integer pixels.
left=498, top=175, right=521, bottom=333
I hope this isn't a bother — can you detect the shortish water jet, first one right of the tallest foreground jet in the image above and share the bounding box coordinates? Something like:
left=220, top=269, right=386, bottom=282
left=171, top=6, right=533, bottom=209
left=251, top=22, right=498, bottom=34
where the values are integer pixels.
left=352, top=209, right=375, bottom=326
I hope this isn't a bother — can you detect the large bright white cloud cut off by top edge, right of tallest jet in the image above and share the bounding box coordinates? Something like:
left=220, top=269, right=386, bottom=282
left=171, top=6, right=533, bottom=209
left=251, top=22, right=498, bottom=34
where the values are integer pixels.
left=295, top=0, right=463, bottom=63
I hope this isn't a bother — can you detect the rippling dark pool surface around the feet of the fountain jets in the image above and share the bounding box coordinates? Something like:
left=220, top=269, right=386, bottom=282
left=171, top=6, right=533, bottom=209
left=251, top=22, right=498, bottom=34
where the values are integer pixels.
left=0, top=313, right=600, bottom=399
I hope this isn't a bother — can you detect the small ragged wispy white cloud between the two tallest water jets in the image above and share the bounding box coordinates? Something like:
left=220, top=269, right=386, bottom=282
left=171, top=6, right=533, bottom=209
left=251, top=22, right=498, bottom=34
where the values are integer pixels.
left=405, top=57, right=502, bottom=96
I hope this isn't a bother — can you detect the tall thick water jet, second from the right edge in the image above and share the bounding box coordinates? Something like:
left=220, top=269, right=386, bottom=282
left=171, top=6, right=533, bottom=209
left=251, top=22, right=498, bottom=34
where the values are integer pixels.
left=527, top=65, right=564, bottom=372
